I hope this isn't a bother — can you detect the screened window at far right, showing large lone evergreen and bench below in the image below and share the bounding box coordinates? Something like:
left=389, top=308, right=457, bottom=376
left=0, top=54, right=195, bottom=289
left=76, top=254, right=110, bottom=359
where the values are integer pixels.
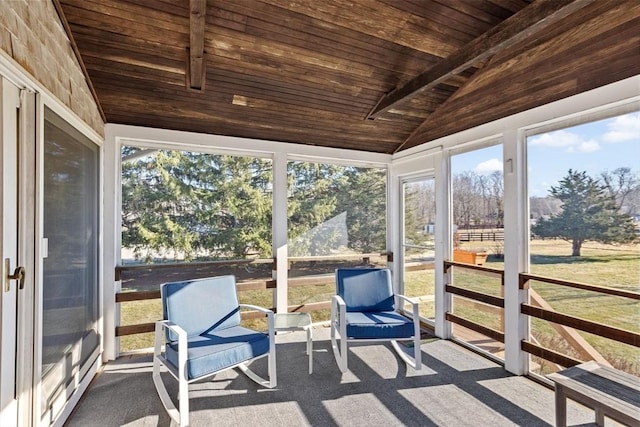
left=527, top=112, right=640, bottom=375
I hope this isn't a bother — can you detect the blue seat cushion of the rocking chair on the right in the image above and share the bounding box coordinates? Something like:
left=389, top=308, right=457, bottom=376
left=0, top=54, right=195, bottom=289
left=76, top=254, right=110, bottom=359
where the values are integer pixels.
left=347, top=311, right=414, bottom=339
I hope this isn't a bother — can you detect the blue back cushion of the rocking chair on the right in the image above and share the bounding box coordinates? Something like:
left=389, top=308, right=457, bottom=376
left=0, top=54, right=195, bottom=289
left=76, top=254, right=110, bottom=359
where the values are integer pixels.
left=336, top=268, right=395, bottom=311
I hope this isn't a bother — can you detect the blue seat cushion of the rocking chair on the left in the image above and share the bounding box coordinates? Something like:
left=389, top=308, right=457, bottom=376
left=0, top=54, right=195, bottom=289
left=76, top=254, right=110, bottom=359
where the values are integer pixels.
left=166, top=326, right=269, bottom=380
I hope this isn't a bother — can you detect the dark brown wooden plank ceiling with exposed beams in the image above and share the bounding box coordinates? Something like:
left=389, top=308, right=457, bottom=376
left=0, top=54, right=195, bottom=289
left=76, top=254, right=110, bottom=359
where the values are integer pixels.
left=54, top=0, right=640, bottom=153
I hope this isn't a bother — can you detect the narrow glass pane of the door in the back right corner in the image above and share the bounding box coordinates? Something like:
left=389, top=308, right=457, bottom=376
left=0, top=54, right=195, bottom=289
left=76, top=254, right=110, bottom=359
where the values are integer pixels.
left=402, top=177, right=436, bottom=321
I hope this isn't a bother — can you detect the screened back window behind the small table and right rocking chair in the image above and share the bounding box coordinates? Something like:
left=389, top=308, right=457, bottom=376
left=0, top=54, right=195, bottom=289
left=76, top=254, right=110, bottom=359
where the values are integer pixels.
left=288, top=161, right=386, bottom=321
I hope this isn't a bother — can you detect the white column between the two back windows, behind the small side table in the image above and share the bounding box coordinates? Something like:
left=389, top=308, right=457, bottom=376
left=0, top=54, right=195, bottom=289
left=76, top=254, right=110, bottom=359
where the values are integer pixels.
left=271, top=151, right=289, bottom=313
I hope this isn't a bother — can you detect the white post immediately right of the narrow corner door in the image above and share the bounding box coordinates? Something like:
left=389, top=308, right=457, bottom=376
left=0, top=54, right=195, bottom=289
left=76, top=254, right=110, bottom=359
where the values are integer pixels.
left=434, top=152, right=453, bottom=338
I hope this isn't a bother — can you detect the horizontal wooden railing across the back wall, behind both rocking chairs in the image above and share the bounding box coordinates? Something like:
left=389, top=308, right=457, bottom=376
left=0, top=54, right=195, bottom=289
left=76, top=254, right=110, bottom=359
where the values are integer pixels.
left=115, top=252, right=393, bottom=337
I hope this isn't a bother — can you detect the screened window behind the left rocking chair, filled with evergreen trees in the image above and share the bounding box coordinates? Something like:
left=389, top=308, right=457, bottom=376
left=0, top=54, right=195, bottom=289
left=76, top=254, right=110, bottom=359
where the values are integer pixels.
left=120, top=146, right=273, bottom=352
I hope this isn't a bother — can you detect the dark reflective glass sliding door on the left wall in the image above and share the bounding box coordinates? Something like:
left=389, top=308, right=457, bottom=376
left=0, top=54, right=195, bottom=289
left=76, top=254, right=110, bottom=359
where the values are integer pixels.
left=40, top=107, right=100, bottom=422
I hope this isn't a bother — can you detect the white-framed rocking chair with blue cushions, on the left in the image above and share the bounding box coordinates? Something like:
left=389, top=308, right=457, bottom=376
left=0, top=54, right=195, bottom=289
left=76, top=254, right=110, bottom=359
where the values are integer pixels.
left=153, top=276, right=277, bottom=427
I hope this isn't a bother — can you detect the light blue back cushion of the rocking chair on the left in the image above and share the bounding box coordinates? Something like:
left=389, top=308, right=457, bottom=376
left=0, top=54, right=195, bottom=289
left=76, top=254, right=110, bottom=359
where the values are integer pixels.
left=160, top=276, right=240, bottom=341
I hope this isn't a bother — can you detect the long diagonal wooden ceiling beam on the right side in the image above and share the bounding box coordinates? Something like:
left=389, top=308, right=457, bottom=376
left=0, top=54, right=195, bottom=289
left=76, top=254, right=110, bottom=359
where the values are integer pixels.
left=367, top=0, right=594, bottom=119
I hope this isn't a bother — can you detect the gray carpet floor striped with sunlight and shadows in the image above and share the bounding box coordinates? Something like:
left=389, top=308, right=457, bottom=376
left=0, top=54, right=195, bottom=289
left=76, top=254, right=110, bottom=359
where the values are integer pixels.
left=67, top=327, right=595, bottom=427
